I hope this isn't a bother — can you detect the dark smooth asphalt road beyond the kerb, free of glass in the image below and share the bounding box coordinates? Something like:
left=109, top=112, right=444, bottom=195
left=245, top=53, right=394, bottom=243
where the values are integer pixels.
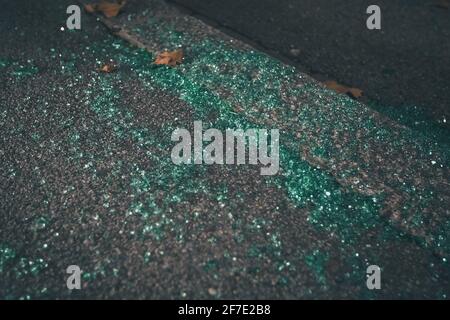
left=171, top=0, right=450, bottom=127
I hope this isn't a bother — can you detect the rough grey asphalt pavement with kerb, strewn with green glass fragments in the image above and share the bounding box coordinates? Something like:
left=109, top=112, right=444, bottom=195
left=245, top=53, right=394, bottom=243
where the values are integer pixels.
left=0, top=0, right=450, bottom=299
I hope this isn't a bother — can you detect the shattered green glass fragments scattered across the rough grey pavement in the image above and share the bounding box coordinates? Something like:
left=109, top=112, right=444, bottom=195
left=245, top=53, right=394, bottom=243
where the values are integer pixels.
left=0, top=7, right=450, bottom=298
